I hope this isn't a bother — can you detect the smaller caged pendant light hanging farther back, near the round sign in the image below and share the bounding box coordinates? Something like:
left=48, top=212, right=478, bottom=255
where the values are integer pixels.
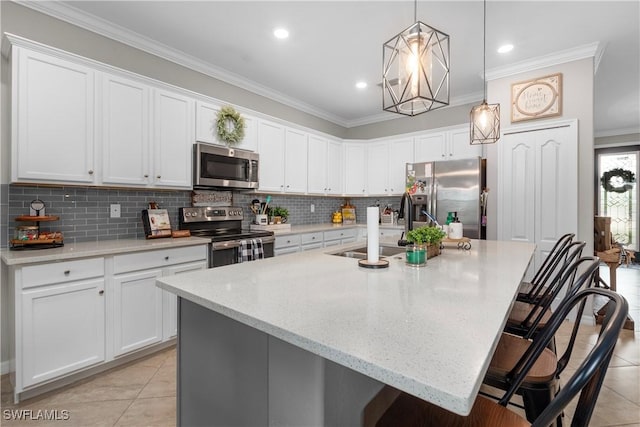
left=471, top=0, right=500, bottom=145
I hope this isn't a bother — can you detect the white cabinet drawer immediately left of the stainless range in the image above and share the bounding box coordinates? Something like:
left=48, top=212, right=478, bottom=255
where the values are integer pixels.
left=113, top=246, right=207, bottom=274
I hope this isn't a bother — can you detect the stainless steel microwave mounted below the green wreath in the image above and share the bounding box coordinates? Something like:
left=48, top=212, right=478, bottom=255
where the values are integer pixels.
left=193, top=142, right=259, bottom=189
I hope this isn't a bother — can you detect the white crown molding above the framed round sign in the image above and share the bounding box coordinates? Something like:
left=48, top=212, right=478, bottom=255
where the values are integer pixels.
left=487, top=42, right=605, bottom=80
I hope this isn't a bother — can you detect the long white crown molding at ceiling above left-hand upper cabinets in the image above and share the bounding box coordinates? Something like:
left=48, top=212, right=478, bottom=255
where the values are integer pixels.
left=11, top=0, right=349, bottom=127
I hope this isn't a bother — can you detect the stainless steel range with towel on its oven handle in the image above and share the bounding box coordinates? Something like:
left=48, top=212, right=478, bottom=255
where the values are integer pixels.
left=179, top=206, right=275, bottom=267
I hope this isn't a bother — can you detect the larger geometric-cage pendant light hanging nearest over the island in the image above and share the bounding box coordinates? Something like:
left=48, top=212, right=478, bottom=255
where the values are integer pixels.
left=382, top=0, right=449, bottom=116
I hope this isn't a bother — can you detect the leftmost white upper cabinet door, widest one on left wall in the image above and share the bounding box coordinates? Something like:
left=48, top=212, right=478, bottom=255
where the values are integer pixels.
left=11, top=47, right=96, bottom=183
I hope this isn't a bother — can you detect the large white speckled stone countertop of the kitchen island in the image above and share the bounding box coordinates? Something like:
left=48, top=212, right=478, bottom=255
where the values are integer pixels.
left=158, top=240, right=535, bottom=414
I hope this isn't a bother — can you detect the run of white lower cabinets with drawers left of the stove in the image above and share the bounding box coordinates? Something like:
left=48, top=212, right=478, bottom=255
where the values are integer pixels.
left=7, top=244, right=207, bottom=398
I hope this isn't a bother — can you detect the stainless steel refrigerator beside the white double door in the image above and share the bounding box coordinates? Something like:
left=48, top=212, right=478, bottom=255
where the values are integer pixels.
left=406, top=157, right=488, bottom=239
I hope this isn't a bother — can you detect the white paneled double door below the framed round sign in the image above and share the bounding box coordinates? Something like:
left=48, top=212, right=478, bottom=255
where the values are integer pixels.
left=498, top=120, right=578, bottom=274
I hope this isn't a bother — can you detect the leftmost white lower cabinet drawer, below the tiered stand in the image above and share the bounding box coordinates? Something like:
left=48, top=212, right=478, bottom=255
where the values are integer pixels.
left=22, top=258, right=104, bottom=289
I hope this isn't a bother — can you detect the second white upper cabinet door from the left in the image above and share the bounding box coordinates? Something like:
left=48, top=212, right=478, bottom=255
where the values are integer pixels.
left=102, top=74, right=151, bottom=185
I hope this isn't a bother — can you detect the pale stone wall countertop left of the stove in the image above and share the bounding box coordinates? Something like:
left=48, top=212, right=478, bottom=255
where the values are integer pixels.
left=0, top=237, right=211, bottom=265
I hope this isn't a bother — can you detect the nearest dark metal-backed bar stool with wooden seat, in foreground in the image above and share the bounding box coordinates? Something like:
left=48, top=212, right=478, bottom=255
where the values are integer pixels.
left=363, top=288, right=628, bottom=427
